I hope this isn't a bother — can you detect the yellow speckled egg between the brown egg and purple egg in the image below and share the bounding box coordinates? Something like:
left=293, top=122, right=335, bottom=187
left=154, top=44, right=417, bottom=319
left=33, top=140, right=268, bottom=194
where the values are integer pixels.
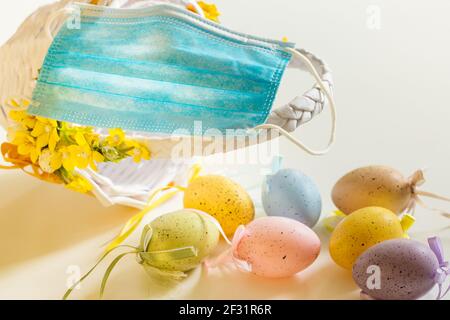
left=329, top=207, right=404, bottom=270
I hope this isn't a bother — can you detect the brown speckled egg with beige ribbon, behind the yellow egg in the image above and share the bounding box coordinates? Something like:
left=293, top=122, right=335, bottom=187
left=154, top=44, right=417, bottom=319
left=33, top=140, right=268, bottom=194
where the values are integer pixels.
left=332, top=166, right=413, bottom=214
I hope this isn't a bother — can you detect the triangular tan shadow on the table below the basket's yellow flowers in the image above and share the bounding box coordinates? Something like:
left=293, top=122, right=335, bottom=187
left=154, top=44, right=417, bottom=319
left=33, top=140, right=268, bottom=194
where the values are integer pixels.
left=0, top=172, right=136, bottom=268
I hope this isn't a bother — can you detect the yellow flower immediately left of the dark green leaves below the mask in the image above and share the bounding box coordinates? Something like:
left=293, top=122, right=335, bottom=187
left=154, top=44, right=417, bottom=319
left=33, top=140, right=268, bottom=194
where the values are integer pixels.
left=61, top=144, right=105, bottom=171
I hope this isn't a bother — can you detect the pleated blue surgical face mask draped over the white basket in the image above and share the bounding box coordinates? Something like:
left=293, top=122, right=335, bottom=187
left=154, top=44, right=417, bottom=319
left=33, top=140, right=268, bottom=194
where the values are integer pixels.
left=29, top=5, right=338, bottom=155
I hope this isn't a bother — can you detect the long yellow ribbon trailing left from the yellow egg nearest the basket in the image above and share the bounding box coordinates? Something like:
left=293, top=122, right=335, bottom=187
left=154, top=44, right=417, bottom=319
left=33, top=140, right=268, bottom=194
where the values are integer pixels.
left=105, top=164, right=201, bottom=252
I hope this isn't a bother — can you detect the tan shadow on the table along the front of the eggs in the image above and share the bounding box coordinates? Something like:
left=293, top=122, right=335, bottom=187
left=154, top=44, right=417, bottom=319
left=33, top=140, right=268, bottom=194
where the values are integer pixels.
left=73, top=257, right=359, bottom=300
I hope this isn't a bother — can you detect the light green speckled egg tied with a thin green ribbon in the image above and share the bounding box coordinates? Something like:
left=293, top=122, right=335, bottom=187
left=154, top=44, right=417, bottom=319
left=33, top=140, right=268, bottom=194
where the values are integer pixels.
left=145, top=209, right=219, bottom=271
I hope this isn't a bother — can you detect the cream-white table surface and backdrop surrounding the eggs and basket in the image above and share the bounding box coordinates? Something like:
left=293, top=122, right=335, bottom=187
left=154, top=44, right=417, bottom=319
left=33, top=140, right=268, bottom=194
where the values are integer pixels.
left=0, top=0, right=450, bottom=299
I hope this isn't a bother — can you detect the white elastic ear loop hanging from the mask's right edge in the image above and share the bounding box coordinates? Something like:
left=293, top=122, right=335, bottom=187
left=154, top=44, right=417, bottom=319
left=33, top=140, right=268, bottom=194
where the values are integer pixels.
left=253, top=48, right=336, bottom=156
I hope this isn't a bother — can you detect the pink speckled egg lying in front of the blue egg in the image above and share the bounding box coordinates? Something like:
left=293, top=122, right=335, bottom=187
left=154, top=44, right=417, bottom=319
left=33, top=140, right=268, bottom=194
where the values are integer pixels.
left=233, top=217, right=320, bottom=278
